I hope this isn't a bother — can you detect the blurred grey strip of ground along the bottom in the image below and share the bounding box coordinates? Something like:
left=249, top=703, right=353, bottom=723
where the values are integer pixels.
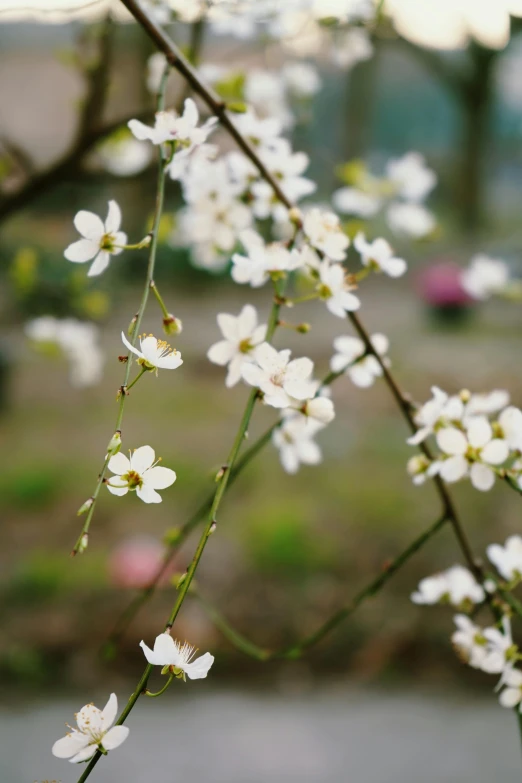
left=7, top=683, right=520, bottom=783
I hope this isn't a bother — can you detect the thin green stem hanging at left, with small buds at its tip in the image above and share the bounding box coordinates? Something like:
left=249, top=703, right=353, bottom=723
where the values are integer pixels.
left=71, top=66, right=170, bottom=556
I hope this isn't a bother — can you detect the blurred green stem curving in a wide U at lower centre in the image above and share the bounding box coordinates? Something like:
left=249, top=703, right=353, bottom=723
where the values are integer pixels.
left=196, top=516, right=447, bottom=661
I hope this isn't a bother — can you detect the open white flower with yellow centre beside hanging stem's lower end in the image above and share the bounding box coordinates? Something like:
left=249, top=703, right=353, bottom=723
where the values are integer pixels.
left=106, top=446, right=176, bottom=503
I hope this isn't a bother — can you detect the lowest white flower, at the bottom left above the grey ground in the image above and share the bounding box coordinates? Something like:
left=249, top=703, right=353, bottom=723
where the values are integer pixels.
left=53, top=693, right=129, bottom=764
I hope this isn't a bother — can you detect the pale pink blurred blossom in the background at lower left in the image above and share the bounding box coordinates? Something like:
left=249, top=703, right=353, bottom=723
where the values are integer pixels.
left=108, top=536, right=176, bottom=588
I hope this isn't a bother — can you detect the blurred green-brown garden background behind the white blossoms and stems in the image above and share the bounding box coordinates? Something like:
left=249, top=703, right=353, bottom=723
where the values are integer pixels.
left=0, top=0, right=522, bottom=783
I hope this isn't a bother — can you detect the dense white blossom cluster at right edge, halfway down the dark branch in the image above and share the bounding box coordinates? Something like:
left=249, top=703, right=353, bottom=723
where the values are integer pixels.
left=408, top=386, right=522, bottom=492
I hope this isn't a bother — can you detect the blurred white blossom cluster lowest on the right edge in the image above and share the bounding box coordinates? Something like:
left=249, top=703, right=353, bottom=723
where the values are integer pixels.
left=411, top=535, right=522, bottom=711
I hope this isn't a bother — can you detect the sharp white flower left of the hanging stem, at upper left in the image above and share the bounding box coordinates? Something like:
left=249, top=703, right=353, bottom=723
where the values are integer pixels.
left=64, top=201, right=127, bottom=277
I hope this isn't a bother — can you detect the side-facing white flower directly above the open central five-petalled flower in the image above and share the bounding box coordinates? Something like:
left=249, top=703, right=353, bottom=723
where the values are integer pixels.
left=231, top=229, right=304, bottom=288
